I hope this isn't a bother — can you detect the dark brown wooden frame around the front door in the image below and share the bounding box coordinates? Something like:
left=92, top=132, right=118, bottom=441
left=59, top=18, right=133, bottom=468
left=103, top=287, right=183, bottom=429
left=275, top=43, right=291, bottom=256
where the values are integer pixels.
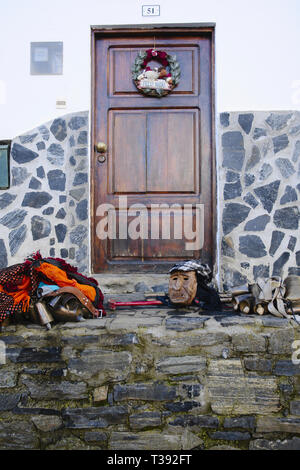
left=90, top=23, right=217, bottom=273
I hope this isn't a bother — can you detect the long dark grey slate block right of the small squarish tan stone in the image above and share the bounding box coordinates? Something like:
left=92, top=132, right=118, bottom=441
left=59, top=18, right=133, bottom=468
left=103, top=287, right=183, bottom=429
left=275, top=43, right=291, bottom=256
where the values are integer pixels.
left=114, top=383, right=177, bottom=401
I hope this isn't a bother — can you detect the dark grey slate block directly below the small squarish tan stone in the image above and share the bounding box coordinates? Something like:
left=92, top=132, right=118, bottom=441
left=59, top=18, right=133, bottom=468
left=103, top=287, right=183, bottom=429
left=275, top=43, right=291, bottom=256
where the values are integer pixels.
left=62, top=406, right=128, bottom=429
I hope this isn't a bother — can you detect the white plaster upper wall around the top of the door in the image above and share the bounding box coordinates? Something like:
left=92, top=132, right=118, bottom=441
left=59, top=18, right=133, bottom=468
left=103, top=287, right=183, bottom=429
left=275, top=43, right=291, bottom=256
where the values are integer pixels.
left=0, top=0, right=300, bottom=139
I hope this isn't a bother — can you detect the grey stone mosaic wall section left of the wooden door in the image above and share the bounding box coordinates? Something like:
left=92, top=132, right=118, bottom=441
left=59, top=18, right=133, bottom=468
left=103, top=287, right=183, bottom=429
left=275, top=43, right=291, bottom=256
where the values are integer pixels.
left=0, top=112, right=89, bottom=273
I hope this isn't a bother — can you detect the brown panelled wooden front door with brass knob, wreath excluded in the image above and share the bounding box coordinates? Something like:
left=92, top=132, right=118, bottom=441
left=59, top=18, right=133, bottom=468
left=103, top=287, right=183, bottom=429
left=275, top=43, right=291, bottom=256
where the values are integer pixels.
left=91, top=26, right=215, bottom=273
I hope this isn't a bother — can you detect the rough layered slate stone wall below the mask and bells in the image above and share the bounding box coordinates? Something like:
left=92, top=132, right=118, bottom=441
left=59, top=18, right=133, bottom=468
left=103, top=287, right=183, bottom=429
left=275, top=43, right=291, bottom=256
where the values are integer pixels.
left=0, top=309, right=300, bottom=450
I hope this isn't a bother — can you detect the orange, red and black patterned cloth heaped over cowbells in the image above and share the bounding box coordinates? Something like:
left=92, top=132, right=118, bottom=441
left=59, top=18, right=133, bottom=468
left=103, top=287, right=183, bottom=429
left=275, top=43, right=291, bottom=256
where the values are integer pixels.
left=0, top=253, right=105, bottom=323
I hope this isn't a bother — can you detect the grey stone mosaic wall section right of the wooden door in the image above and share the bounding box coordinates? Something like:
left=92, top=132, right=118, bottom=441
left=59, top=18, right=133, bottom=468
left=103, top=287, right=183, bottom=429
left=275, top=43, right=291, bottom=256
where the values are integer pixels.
left=218, top=112, right=300, bottom=289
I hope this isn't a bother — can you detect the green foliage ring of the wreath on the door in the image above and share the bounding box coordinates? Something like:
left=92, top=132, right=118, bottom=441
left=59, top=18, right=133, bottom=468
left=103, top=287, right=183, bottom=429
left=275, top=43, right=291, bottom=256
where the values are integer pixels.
left=131, top=51, right=181, bottom=98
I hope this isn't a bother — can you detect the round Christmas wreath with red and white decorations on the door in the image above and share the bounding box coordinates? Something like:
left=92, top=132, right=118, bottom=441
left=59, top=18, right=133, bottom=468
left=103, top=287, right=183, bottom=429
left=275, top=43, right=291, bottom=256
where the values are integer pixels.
left=132, top=49, right=180, bottom=98
